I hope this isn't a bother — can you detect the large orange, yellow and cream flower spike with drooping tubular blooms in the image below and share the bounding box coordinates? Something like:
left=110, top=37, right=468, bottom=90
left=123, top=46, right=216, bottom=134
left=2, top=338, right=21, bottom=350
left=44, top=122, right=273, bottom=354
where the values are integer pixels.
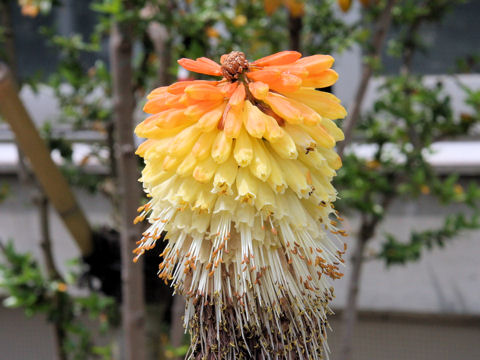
left=134, top=51, right=346, bottom=360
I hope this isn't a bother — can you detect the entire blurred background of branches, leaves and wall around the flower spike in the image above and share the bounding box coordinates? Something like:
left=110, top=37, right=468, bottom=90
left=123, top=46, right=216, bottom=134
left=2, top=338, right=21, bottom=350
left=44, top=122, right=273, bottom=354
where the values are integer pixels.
left=0, top=0, right=480, bottom=360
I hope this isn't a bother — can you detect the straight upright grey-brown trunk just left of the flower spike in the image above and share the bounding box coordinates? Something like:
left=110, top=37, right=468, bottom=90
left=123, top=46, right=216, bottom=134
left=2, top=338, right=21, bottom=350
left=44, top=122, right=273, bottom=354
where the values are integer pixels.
left=110, top=11, right=146, bottom=360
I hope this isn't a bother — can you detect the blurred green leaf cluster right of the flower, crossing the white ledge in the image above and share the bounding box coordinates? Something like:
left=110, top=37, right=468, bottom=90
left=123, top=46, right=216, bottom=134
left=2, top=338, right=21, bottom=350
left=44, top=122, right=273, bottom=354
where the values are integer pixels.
left=337, top=76, right=480, bottom=264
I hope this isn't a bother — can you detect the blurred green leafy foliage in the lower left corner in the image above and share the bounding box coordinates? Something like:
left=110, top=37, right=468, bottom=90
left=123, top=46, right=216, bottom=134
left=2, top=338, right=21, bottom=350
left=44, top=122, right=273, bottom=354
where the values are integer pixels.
left=0, top=242, right=118, bottom=360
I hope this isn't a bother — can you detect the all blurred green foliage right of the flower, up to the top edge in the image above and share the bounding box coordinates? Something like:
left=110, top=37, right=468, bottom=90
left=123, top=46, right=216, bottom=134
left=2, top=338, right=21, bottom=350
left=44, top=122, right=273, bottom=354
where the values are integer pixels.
left=337, top=0, right=480, bottom=265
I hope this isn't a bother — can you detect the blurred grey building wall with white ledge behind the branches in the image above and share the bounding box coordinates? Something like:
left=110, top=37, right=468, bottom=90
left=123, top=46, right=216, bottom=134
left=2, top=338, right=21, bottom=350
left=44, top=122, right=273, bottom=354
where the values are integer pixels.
left=0, top=1, right=480, bottom=360
